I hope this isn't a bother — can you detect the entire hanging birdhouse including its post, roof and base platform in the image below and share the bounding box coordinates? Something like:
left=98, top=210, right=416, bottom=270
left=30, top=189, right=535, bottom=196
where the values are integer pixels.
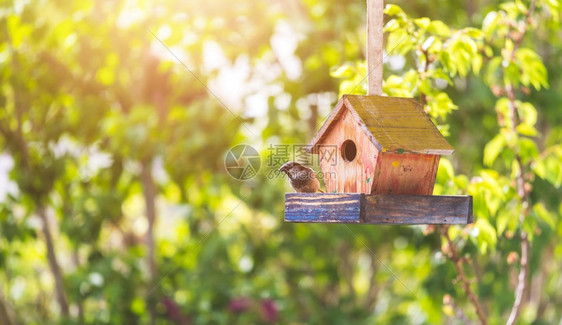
left=285, top=0, right=473, bottom=225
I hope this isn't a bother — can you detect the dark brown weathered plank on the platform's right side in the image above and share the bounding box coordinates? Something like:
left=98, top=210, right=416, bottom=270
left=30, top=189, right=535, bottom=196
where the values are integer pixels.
left=364, top=195, right=473, bottom=225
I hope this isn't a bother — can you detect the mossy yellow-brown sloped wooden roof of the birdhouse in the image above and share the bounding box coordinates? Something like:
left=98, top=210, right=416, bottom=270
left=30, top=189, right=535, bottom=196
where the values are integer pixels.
left=308, top=95, right=454, bottom=155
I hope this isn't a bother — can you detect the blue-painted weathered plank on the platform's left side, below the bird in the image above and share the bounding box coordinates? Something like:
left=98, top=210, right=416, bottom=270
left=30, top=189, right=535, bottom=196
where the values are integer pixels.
left=285, top=193, right=361, bottom=223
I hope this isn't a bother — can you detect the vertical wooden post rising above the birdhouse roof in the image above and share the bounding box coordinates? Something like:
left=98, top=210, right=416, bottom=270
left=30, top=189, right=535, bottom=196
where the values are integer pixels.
left=367, top=0, right=384, bottom=96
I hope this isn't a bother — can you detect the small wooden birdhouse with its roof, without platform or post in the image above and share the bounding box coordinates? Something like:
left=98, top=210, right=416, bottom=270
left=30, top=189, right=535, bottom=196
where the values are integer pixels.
left=309, top=95, right=454, bottom=195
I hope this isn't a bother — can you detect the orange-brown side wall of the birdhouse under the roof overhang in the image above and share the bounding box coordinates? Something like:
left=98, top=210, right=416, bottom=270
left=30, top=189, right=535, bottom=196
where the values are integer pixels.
left=373, top=152, right=440, bottom=195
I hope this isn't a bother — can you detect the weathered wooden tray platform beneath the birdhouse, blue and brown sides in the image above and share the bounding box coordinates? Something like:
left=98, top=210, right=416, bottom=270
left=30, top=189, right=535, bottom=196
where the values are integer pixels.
left=285, top=193, right=473, bottom=225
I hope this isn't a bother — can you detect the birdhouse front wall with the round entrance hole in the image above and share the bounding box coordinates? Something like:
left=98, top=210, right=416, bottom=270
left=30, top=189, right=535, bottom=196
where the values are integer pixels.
left=318, top=109, right=379, bottom=194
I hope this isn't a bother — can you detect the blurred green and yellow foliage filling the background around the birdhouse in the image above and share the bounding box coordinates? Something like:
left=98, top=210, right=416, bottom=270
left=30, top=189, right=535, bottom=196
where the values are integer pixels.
left=0, top=0, right=562, bottom=324
